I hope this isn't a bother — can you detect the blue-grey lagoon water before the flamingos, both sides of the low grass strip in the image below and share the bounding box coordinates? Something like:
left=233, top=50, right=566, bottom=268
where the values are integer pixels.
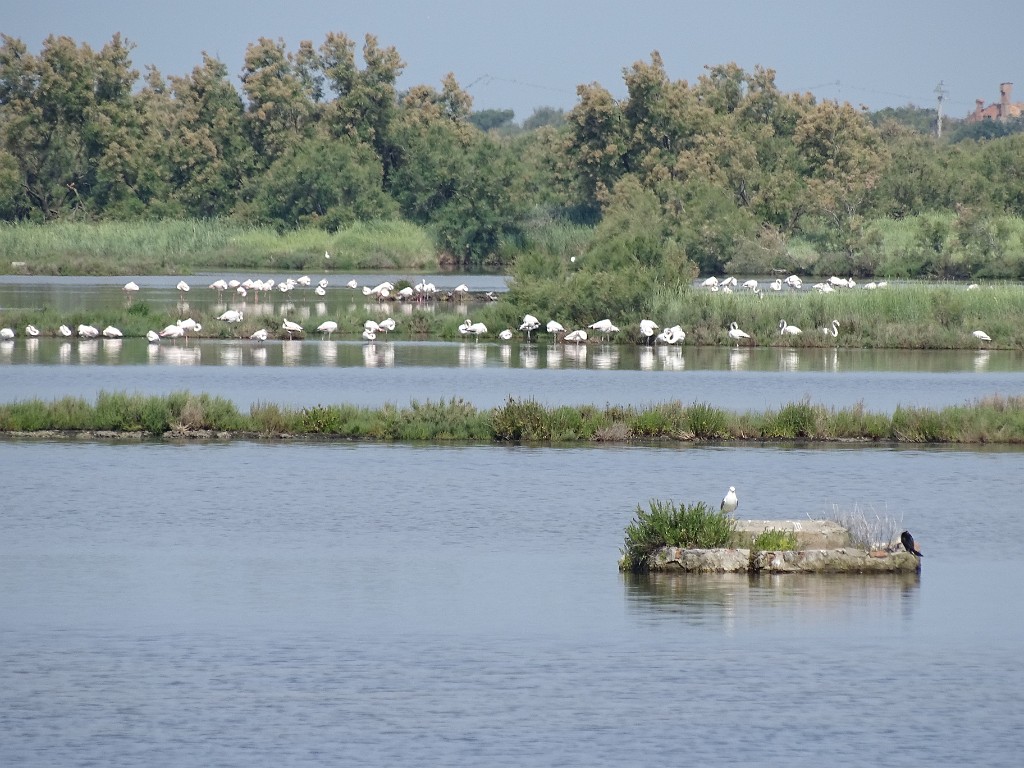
left=0, top=280, right=1024, bottom=767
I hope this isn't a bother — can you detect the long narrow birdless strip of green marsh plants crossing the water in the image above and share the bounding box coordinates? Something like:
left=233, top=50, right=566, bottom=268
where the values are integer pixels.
left=0, top=391, right=1024, bottom=444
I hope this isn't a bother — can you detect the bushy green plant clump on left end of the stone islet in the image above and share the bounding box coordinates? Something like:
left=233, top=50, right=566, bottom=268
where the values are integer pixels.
left=622, top=499, right=736, bottom=571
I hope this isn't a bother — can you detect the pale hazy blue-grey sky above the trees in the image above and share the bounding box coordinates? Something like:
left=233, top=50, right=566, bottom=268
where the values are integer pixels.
left=8, top=0, right=1024, bottom=122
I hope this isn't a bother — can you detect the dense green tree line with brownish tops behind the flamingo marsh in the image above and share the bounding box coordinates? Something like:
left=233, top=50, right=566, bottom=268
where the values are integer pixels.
left=0, top=33, right=1024, bottom=279
